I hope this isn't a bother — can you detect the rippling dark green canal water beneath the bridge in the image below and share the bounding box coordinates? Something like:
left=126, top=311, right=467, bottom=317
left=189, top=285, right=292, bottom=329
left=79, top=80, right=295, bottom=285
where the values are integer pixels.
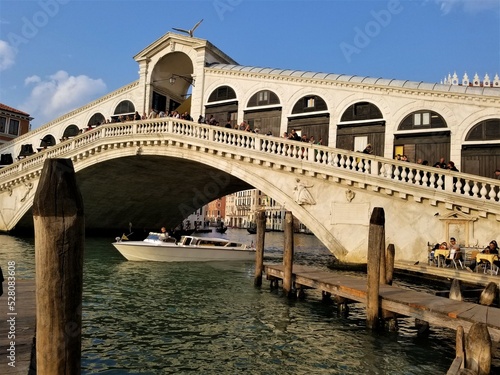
left=0, top=229, right=498, bottom=375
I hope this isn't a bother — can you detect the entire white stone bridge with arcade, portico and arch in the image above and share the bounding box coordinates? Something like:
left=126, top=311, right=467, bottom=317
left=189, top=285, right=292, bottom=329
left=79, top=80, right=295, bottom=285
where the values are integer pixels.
left=0, top=33, right=500, bottom=262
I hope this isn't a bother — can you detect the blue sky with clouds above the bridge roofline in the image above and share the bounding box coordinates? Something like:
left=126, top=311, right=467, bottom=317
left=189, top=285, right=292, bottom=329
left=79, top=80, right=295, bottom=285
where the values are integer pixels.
left=0, top=0, right=500, bottom=128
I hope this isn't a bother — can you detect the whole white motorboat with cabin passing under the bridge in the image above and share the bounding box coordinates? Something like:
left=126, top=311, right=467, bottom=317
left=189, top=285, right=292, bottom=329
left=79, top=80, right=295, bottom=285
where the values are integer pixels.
left=113, top=232, right=255, bottom=262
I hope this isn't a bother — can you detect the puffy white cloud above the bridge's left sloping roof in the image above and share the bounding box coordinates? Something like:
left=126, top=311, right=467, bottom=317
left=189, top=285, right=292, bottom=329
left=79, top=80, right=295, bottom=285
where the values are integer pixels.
left=20, top=70, right=106, bottom=125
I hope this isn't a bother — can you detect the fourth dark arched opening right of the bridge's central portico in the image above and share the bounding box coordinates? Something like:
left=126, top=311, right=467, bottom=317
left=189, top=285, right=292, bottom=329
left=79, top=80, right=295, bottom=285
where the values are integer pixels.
left=337, top=102, right=385, bottom=156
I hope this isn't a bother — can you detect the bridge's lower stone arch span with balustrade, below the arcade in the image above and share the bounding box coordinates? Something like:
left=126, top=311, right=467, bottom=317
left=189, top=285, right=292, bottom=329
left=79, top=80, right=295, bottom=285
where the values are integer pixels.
left=0, top=118, right=500, bottom=262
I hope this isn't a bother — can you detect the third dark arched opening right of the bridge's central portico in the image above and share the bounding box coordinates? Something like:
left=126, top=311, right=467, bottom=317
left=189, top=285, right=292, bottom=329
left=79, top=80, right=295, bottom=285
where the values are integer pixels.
left=287, top=95, right=330, bottom=145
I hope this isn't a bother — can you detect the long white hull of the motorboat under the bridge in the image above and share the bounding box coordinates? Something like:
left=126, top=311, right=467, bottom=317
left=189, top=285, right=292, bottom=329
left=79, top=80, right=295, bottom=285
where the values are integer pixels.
left=113, top=241, right=255, bottom=262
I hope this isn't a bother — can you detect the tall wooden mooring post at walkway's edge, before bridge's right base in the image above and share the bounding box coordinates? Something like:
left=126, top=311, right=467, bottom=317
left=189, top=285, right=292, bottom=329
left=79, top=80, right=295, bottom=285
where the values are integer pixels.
left=366, top=207, right=385, bottom=329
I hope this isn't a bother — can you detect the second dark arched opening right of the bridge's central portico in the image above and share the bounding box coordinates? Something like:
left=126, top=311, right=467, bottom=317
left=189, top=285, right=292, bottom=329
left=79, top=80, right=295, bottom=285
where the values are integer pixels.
left=245, top=90, right=281, bottom=136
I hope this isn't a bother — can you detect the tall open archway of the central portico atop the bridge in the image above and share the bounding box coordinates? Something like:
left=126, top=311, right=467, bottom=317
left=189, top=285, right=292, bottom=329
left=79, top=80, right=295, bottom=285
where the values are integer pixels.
left=149, top=52, right=195, bottom=117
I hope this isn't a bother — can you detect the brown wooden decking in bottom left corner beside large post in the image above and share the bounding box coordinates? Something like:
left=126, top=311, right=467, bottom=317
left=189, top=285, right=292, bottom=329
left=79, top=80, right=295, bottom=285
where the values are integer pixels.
left=0, top=280, right=36, bottom=375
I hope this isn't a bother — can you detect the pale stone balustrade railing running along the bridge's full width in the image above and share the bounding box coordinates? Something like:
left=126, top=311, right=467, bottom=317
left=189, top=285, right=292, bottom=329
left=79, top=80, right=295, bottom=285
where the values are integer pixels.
left=0, top=117, right=500, bottom=203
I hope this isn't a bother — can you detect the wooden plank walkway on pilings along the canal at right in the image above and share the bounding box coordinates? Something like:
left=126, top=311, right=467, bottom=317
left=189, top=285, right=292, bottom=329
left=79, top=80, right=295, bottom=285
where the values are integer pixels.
left=264, top=264, right=500, bottom=342
